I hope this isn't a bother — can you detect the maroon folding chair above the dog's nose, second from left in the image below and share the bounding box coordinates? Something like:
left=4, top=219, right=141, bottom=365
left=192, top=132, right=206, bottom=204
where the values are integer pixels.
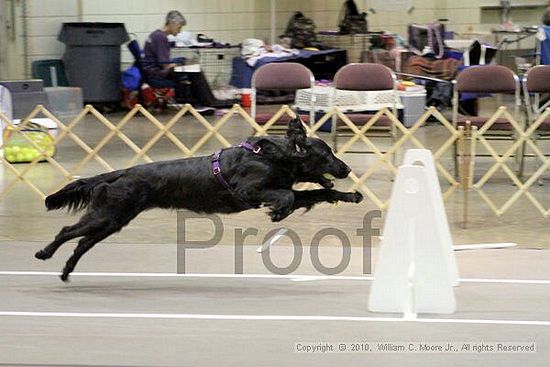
left=331, top=63, right=398, bottom=153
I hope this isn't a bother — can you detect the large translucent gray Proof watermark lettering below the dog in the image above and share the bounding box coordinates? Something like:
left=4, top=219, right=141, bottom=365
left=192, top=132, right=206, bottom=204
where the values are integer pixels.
left=177, top=210, right=382, bottom=275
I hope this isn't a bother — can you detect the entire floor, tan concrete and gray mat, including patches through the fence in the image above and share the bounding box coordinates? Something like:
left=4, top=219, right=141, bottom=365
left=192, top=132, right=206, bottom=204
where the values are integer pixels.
left=0, top=108, right=550, bottom=366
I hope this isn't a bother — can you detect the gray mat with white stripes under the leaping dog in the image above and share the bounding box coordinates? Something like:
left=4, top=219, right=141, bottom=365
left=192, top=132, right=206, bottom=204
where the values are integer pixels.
left=0, top=242, right=550, bottom=366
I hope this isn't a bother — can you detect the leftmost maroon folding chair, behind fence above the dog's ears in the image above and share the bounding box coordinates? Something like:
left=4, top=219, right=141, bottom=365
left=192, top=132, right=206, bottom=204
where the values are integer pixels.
left=250, top=62, right=315, bottom=132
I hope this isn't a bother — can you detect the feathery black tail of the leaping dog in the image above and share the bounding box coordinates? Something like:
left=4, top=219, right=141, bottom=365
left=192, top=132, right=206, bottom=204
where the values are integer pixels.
left=46, top=171, right=124, bottom=212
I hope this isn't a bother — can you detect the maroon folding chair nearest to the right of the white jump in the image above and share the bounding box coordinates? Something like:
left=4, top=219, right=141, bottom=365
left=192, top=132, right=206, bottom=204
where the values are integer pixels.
left=452, top=64, right=525, bottom=176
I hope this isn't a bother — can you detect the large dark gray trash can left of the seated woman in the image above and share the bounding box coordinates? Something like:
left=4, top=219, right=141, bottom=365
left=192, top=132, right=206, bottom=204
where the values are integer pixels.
left=57, top=22, right=129, bottom=103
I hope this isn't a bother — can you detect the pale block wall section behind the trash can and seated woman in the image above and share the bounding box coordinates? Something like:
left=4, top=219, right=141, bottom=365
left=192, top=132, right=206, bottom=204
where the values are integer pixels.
left=22, top=0, right=280, bottom=75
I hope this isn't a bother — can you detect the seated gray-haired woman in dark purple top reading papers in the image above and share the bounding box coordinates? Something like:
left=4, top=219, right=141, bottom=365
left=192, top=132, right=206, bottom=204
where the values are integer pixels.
left=142, top=10, right=237, bottom=107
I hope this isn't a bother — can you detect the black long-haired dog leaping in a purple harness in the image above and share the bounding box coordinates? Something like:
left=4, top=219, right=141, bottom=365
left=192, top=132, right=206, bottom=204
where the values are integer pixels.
left=35, top=119, right=363, bottom=281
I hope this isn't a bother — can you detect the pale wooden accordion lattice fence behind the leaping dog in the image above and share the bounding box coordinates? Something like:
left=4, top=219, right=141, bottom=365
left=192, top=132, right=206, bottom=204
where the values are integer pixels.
left=0, top=105, right=550, bottom=217
